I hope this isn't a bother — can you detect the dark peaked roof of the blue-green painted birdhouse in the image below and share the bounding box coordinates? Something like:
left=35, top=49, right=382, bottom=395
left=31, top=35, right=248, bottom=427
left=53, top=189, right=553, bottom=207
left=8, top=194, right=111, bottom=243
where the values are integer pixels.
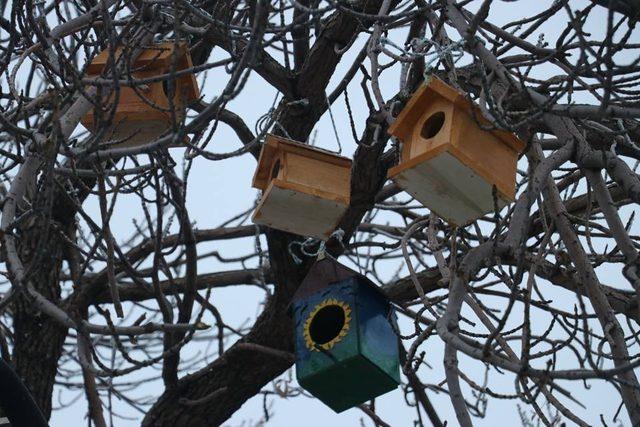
left=292, top=255, right=384, bottom=302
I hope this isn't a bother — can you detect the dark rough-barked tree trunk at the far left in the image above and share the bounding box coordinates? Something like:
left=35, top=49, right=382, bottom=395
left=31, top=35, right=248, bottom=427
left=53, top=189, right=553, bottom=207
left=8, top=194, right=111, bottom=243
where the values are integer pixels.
left=12, top=163, right=95, bottom=419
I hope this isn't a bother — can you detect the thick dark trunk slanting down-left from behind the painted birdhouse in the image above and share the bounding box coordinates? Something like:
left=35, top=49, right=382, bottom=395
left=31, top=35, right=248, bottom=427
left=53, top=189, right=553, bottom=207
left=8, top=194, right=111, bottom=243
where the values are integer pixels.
left=142, top=231, right=307, bottom=427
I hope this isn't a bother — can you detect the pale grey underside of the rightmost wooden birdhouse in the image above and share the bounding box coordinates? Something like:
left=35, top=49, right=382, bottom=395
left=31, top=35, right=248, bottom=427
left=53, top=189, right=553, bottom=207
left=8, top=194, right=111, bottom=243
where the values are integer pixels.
left=389, top=146, right=510, bottom=225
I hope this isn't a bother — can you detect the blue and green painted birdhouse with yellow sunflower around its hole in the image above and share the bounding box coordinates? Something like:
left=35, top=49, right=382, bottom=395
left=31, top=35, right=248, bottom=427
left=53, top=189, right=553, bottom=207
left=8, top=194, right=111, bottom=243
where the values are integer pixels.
left=290, top=256, right=400, bottom=412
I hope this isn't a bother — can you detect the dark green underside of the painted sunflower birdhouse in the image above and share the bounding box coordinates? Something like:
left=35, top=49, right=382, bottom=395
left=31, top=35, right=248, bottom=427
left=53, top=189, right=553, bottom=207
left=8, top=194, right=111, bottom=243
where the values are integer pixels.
left=298, top=355, right=398, bottom=412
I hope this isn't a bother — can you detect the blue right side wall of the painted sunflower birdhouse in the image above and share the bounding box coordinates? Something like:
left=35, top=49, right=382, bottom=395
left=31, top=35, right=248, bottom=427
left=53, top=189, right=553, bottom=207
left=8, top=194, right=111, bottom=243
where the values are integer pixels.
left=356, top=279, right=400, bottom=388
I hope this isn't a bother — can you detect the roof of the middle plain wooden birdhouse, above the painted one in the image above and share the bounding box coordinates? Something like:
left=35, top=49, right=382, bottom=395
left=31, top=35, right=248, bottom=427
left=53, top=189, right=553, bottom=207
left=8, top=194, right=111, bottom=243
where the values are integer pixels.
left=253, top=134, right=351, bottom=190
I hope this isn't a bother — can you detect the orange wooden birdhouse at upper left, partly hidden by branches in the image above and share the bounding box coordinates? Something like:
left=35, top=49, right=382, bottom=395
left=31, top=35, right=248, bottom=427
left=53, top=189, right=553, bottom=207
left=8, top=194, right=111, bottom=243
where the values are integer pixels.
left=82, top=42, right=200, bottom=147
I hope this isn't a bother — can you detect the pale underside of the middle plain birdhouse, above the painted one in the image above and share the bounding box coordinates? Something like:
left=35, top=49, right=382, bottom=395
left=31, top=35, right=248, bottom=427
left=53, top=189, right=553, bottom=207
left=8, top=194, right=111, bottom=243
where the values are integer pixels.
left=253, top=180, right=347, bottom=240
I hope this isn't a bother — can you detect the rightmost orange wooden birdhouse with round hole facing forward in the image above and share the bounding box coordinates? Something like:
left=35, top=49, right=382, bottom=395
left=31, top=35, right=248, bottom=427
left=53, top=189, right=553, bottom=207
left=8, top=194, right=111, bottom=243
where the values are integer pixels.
left=389, top=78, right=524, bottom=225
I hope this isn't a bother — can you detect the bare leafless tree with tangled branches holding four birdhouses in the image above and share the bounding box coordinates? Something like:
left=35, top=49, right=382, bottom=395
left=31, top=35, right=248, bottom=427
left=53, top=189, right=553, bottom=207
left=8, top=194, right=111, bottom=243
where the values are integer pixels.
left=0, top=0, right=640, bottom=426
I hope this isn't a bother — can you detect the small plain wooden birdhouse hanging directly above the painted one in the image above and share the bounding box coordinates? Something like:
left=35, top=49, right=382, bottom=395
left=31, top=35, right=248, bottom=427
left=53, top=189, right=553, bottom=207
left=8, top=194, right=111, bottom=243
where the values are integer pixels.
left=253, top=135, right=351, bottom=240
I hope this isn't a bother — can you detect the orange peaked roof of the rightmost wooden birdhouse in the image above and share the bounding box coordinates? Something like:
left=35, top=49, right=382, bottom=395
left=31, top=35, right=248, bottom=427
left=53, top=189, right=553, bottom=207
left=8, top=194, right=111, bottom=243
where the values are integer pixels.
left=388, top=77, right=525, bottom=153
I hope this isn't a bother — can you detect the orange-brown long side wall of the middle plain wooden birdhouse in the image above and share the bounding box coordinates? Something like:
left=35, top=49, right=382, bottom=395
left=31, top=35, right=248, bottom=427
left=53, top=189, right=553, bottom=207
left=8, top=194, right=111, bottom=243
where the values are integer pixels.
left=283, top=152, right=351, bottom=201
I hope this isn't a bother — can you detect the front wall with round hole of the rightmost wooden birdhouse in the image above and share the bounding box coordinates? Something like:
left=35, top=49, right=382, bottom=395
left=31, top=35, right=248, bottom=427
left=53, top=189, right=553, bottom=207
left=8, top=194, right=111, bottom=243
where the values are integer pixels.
left=402, top=99, right=454, bottom=161
